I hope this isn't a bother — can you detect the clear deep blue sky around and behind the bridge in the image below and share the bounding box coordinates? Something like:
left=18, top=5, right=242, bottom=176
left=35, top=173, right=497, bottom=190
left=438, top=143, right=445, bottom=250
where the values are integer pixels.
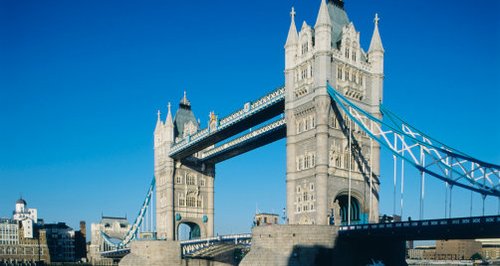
left=0, top=0, right=500, bottom=234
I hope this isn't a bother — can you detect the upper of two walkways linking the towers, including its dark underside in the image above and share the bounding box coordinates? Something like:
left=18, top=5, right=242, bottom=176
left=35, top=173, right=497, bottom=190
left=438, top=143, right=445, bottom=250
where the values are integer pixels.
left=169, top=87, right=285, bottom=160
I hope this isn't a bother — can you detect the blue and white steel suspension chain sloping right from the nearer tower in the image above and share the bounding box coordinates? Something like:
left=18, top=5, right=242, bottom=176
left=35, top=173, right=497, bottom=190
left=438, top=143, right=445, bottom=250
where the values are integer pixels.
left=327, top=84, right=500, bottom=197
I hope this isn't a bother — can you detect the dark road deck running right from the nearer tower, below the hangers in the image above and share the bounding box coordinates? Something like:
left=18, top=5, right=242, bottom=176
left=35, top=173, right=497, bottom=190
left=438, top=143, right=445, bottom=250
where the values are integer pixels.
left=339, top=215, right=500, bottom=240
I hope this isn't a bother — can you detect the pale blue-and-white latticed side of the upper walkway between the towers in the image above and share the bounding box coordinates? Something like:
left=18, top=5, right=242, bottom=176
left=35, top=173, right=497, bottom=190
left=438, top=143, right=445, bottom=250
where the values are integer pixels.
left=169, top=87, right=285, bottom=156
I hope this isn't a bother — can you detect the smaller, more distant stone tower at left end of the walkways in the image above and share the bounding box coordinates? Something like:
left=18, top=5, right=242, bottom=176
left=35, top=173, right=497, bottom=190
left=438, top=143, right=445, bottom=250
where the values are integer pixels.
left=154, top=93, right=215, bottom=240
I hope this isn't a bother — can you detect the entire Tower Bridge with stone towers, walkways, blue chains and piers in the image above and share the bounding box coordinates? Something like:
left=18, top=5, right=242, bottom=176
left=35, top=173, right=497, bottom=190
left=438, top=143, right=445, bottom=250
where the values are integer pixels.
left=92, top=0, right=500, bottom=265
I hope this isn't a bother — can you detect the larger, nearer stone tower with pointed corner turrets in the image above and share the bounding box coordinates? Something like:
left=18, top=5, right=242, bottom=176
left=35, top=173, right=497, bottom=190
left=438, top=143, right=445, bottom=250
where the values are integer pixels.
left=285, top=0, right=384, bottom=225
